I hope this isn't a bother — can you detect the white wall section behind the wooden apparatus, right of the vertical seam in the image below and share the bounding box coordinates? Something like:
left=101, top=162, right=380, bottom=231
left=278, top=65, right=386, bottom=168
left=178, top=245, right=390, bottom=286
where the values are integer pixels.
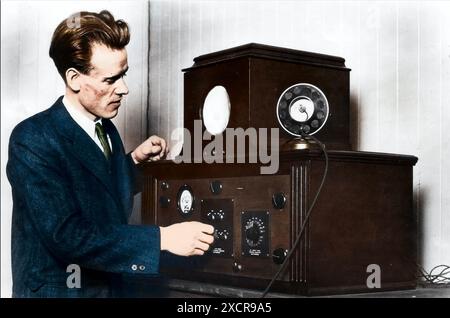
left=149, top=0, right=450, bottom=278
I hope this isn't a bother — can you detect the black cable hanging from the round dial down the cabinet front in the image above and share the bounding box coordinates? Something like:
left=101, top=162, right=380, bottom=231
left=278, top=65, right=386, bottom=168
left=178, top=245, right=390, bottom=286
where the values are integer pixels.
left=261, top=135, right=328, bottom=298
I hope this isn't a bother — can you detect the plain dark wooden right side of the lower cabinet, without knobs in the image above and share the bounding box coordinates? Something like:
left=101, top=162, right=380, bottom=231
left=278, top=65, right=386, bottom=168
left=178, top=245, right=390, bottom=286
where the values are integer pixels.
left=308, top=162, right=417, bottom=292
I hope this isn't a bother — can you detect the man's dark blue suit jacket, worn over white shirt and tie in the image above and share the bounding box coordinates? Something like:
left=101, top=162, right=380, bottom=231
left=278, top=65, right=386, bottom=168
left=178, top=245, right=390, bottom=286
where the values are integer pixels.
left=7, top=97, right=160, bottom=297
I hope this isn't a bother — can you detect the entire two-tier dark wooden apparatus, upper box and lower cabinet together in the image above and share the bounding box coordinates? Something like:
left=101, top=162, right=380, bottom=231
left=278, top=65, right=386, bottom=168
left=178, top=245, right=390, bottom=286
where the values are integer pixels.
left=141, top=43, right=417, bottom=295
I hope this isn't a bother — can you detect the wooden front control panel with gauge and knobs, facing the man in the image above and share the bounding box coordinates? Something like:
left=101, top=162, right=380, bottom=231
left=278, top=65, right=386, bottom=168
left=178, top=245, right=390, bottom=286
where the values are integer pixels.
left=156, top=174, right=291, bottom=279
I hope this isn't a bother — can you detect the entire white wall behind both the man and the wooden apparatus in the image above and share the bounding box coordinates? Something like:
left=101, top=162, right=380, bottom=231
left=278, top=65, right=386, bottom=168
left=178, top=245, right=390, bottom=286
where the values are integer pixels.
left=1, top=0, right=450, bottom=297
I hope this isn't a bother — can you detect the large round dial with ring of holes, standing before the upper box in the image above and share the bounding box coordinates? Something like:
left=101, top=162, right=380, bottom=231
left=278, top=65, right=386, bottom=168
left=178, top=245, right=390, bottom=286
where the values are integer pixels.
left=277, top=83, right=329, bottom=137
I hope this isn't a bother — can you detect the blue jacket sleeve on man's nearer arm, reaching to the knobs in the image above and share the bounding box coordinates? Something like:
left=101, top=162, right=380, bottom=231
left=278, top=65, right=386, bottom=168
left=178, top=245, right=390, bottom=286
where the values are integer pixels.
left=7, top=124, right=160, bottom=274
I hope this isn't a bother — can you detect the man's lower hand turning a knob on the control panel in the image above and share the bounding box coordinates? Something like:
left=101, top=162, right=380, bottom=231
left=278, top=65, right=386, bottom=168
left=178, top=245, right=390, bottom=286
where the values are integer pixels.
left=160, top=221, right=214, bottom=256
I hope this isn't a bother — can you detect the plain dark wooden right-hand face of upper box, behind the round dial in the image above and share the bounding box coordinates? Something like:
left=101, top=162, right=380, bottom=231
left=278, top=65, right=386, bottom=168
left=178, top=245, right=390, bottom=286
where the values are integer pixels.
left=249, top=58, right=350, bottom=150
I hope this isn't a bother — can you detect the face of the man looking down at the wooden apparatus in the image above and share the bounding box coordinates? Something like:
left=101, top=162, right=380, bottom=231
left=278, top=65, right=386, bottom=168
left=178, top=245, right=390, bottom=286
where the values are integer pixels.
left=78, top=44, right=128, bottom=118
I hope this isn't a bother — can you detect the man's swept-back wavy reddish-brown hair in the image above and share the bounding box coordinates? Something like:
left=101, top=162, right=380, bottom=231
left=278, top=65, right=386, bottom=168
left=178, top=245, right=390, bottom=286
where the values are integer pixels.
left=49, top=10, right=130, bottom=82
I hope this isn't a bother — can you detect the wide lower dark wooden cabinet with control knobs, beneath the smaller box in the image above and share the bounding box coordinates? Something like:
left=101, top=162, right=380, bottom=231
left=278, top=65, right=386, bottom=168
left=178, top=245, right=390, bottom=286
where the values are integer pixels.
left=141, top=150, right=417, bottom=295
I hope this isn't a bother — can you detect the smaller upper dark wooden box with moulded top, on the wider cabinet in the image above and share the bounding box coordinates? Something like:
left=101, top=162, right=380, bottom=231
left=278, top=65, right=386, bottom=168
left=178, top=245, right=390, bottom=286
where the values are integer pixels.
left=183, top=43, right=351, bottom=150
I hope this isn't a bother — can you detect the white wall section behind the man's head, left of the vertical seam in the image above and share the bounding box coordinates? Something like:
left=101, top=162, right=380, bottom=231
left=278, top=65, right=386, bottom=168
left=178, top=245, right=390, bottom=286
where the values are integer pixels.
left=1, top=1, right=149, bottom=297
